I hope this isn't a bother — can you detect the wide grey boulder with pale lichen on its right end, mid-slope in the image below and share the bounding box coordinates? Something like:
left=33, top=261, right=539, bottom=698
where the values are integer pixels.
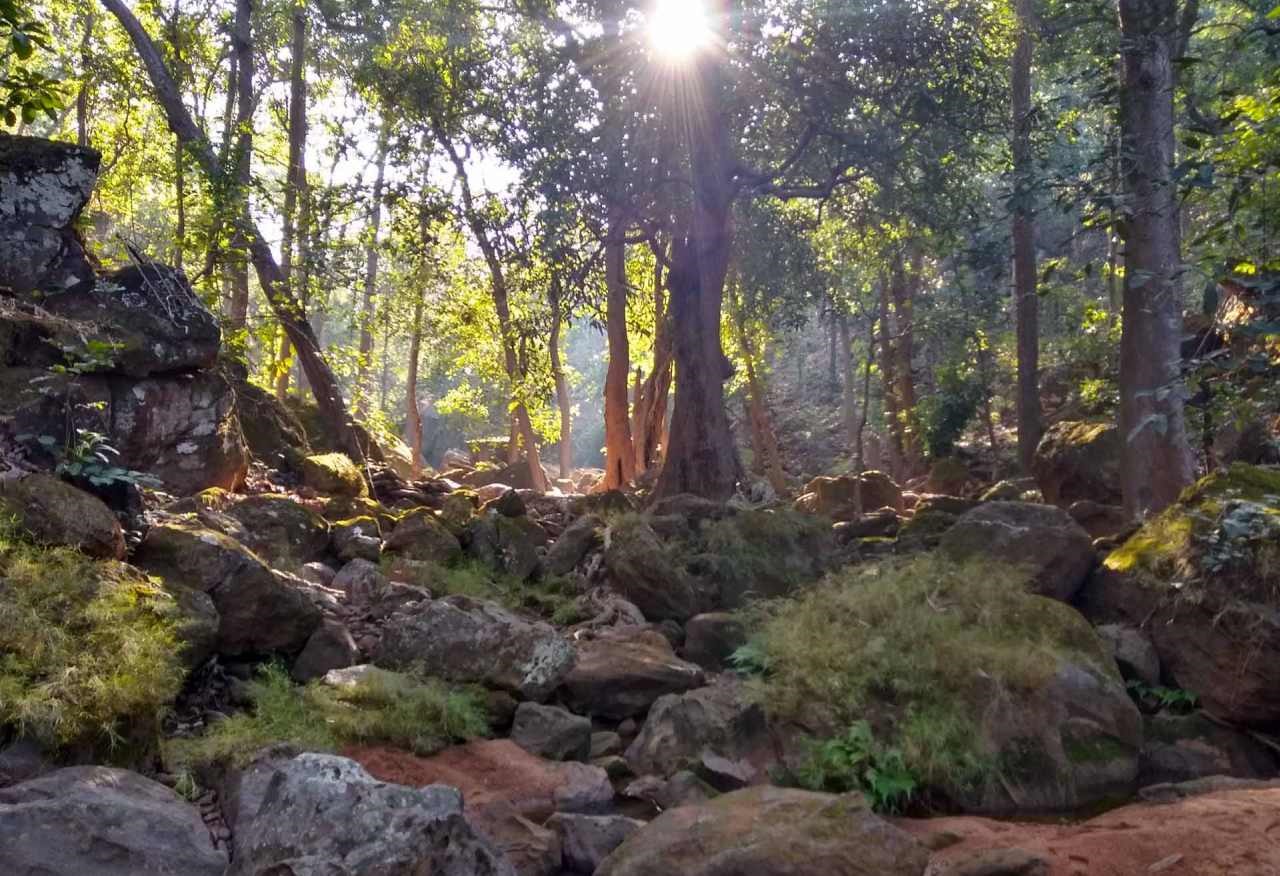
left=374, top=596, right=575, bottom=701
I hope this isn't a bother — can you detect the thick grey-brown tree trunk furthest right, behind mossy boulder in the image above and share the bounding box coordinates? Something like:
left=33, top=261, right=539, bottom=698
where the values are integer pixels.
left=1120, top=0, right=1194, bottom=516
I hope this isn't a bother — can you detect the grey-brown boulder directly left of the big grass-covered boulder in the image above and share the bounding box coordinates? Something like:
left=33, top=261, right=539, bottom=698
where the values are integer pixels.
left=626, top=680, right=773, bottom=784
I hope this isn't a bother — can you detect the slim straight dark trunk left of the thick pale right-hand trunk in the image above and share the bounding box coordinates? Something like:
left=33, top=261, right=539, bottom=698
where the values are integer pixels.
left=1012, top=0, right=1042, bottom=474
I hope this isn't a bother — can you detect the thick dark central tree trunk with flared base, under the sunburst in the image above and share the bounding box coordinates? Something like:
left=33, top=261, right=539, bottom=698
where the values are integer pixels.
left=654, top=0, right=742, bottom=498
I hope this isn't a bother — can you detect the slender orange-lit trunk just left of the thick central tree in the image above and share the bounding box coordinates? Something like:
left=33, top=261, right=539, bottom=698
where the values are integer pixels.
left=600, top=224, right=636, bottom=489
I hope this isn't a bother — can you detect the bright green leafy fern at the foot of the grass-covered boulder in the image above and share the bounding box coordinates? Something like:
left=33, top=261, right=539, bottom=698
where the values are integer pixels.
left=796, top=721, right=919, bottom=812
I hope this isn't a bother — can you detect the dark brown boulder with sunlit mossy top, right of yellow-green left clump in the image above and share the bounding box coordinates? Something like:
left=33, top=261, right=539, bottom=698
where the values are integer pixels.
left=136, top=520, right=320, bottom=656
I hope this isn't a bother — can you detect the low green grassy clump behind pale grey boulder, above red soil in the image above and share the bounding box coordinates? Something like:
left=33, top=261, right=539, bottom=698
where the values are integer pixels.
left=165, top=665, right=489, bottom=770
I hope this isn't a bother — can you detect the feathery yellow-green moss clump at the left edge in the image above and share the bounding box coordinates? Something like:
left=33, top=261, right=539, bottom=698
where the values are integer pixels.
left=0, top=522, right=184, bottom=757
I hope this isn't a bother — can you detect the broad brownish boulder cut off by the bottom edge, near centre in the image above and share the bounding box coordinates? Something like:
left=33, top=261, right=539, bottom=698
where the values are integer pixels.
left=595, top=786, right=929, bottom=876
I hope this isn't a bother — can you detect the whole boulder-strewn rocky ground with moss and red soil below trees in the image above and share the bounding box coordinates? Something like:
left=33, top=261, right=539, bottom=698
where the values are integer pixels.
left=0, top=131, right=1280, bottom=876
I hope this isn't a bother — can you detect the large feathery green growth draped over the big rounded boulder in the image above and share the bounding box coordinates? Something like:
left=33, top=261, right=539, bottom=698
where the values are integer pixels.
left=750, top=555, right=1110, bottom=788
